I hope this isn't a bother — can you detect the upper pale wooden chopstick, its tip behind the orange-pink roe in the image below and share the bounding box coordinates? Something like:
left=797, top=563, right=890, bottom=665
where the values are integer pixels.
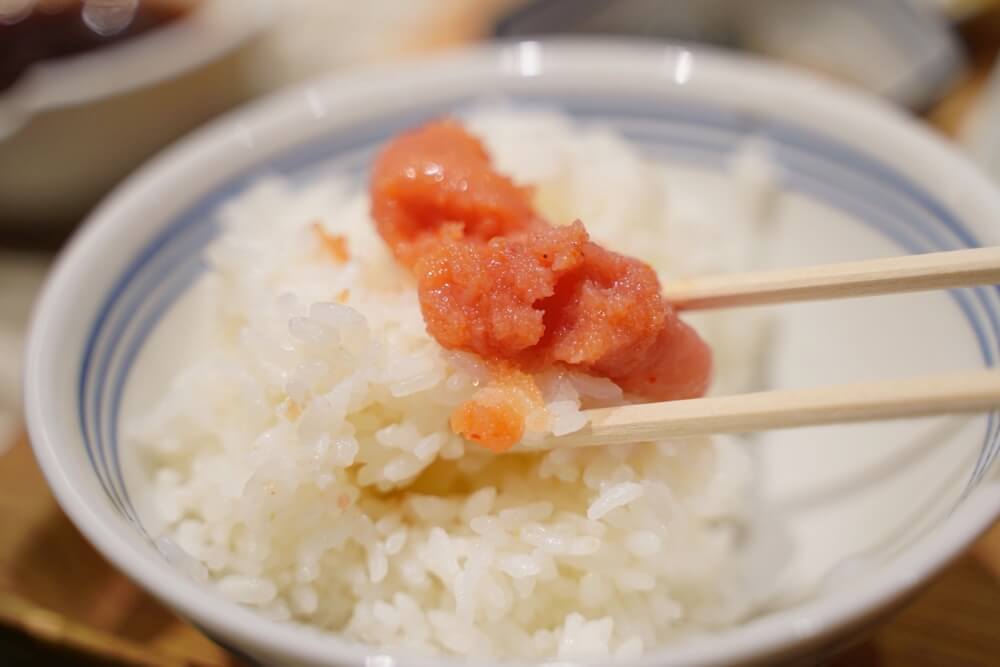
left=664, top=248, right=1000, bottom=310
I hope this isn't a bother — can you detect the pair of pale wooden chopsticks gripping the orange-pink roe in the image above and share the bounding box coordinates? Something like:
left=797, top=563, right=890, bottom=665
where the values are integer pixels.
left=539, top=248, right=1000, bottom=449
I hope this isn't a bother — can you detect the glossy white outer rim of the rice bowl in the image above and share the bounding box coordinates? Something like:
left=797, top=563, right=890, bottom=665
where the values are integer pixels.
left=25, top=40, right=1000, bottom=667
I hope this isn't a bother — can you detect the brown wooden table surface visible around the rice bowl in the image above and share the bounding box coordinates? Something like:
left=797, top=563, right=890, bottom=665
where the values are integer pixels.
left=0, top=6, right=1000, bottom=667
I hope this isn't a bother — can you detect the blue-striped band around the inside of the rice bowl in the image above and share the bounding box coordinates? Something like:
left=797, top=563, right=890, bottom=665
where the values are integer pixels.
left=79, top=95, right=1000, bottom=528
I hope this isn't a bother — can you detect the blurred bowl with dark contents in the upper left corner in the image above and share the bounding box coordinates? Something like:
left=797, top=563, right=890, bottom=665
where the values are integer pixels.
left=0, top=0, right=270, bottom=237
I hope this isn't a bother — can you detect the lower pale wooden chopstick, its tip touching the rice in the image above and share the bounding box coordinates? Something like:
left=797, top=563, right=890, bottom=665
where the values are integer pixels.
left=536, top=369, right=1000, bottom=451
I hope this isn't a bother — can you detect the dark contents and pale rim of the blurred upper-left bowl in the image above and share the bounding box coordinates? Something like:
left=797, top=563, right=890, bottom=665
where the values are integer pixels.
left=0, top=0, right=269, bottom=129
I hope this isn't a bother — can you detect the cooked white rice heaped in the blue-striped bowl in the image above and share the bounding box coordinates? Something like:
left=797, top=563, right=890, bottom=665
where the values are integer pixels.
left=126, top=108, right=773, bottom=658
